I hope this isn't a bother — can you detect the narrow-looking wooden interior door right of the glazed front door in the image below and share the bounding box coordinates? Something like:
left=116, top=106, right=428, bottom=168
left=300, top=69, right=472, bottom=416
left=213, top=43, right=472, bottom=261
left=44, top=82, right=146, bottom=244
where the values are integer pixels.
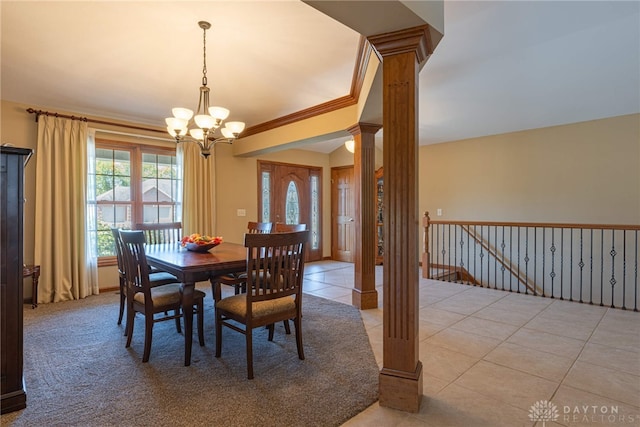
left=331, top=166, right=355, bottom=262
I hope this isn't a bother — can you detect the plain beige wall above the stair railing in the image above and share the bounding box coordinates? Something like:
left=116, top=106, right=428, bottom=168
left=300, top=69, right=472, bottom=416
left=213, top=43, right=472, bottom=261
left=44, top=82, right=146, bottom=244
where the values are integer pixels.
left=419, top=114, right=640, bottom=224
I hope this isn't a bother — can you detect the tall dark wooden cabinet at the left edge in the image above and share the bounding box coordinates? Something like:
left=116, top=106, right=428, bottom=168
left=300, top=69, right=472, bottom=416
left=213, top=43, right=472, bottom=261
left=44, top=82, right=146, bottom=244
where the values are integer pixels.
left=0, top=147, right=32, bottom=414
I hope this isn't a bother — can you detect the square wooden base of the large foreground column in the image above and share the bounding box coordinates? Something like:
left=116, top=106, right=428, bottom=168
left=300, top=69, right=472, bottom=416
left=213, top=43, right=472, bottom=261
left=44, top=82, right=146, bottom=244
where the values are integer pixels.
left=378, top=361, right=422, bottom=412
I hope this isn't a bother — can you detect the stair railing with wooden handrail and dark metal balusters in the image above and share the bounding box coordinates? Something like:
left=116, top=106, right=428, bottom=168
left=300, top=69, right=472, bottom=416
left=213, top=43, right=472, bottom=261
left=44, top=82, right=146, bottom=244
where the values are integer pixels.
left=422, top=212, right=640, bottom=311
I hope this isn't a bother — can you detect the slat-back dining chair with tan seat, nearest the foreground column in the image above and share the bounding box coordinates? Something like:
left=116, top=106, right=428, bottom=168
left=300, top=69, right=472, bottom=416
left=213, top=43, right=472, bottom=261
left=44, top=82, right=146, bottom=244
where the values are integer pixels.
left=214, top=231, right=309, bottom=379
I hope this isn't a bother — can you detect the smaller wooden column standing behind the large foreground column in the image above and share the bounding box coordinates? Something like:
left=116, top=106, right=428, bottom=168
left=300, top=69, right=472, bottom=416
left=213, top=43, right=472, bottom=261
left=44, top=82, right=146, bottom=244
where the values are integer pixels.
left=347, top=123, right=381, bottom=310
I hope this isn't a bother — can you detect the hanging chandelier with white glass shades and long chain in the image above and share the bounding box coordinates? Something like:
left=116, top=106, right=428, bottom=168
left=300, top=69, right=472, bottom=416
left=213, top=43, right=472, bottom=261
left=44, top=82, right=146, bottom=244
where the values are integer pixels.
left=165, top=21, right=244, bottom=159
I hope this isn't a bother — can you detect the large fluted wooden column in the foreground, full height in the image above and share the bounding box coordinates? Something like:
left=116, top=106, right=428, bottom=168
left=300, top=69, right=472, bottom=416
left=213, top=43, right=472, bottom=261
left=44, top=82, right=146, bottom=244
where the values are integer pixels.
left=369, top=25, right=432, bottom=412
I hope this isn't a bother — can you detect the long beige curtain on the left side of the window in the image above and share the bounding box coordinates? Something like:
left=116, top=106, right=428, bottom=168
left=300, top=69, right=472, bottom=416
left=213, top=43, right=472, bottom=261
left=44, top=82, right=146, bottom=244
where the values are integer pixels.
left=34, top=115, right=98, bottom=303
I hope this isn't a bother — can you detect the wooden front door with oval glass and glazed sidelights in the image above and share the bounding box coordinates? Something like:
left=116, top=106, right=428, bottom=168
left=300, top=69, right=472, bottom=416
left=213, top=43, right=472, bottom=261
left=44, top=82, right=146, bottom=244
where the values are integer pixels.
left=258, top=160, right=322, bottom=261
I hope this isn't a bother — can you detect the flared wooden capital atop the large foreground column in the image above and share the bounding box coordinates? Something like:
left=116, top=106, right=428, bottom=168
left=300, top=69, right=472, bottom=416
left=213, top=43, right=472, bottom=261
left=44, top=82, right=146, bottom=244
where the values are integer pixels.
left=367, top=25, right=434, bottom=64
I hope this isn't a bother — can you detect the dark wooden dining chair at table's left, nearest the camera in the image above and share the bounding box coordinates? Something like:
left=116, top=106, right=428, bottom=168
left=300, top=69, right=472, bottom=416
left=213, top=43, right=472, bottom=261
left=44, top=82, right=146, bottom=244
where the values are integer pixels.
left=119, top=230, right=205, bottom=365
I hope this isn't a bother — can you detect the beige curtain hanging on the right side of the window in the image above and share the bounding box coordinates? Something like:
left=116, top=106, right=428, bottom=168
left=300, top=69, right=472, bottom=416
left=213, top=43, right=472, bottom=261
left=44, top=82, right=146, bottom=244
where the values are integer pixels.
left=178, top=142, right=216, bottom=236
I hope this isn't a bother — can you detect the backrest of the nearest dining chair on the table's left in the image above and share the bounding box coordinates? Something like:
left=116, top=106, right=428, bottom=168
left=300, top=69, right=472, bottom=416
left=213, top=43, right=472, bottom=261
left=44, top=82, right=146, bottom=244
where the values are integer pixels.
left=119, top=230, right=151, bottom=301
